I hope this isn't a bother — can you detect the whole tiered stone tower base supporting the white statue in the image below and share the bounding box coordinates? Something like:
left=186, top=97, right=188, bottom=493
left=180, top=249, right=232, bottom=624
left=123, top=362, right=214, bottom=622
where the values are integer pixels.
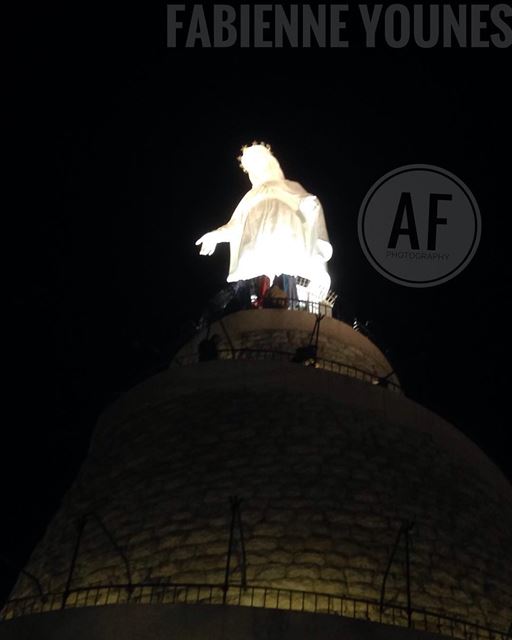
left=0, top=309, right=512, bottom=640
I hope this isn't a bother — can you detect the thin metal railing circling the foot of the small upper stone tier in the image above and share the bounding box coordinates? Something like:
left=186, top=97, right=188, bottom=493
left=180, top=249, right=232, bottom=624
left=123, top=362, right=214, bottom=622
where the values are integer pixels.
left=174, top=348, right=402, bottom=393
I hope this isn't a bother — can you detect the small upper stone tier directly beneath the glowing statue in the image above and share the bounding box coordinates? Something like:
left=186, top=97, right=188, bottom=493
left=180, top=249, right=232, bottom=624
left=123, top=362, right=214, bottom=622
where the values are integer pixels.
left=171, top=308, right=401, bottom=393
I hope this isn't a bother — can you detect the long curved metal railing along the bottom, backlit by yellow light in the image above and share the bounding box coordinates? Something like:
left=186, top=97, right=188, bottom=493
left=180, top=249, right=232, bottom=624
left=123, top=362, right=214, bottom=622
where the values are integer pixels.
left=0, top=582, right=512, bottom=640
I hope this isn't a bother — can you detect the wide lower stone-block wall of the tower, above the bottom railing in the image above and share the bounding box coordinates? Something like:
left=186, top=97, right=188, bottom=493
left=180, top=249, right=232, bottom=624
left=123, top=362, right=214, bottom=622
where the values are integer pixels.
left=6, top=361, right=512, bottom=629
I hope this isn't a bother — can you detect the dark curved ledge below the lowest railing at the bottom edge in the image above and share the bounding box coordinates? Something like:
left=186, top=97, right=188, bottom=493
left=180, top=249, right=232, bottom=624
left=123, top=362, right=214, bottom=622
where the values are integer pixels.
left=0, top=605, right=448, bottom=640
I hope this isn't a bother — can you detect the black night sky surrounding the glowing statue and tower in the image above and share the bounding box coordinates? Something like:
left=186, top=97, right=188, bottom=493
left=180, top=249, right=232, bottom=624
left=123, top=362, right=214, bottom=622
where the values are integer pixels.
left=0, top=3, right=512, bottom=604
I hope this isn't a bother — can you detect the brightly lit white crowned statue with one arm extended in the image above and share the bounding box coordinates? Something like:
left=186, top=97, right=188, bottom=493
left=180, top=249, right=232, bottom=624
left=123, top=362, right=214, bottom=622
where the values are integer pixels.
left=196, top=143, right=332, bottom=300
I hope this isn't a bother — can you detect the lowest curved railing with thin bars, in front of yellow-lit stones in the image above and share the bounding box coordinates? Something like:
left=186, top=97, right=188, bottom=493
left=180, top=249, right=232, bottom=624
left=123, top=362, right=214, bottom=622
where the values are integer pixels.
left=0, top=581, right=511, bottom=640
